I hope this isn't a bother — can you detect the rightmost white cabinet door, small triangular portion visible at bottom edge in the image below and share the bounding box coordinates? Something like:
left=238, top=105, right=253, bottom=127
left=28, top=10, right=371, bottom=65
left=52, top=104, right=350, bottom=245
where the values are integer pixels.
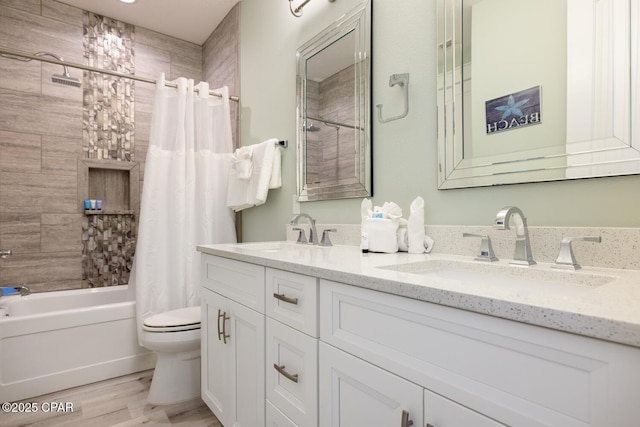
left=424, top=390, right=506, bottom=427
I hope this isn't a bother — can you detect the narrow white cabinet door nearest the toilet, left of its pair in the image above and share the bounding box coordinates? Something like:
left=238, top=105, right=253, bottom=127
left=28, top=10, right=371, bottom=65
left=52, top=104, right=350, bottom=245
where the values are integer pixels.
left=200, top=288, right=229, bottom=423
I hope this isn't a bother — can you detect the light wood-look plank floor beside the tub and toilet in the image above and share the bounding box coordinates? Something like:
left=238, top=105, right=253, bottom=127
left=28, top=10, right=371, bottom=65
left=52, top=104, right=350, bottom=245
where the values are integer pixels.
left=0, top=370, right=222, bottom=427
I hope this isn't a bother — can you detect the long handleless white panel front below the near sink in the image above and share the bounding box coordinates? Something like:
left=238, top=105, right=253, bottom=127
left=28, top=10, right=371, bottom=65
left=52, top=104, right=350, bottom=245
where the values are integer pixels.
left=320, top=280, right=640, bottom=426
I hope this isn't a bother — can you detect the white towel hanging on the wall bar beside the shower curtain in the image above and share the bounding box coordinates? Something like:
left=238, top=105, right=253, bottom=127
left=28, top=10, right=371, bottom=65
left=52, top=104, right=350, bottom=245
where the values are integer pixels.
left=227, top=138, right=282, bottom=212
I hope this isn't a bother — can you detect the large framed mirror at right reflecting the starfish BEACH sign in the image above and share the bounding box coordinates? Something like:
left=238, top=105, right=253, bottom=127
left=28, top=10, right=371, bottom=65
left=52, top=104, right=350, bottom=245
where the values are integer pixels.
left=437, top=0, right=640, bottom=189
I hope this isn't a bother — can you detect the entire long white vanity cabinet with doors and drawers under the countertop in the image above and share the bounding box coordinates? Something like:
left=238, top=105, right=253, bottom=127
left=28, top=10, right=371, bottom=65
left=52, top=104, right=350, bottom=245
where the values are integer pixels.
left=202, top=254, right=640, bottom=427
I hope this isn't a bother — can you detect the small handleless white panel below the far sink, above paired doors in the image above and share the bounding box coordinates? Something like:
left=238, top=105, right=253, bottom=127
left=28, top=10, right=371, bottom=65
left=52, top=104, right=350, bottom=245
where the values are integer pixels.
left=200, top=254, right=264, bottom=314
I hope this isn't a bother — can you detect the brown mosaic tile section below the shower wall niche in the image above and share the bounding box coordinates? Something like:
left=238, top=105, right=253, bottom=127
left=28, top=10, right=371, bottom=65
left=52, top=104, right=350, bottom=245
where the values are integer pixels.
left=82, top=215, right=136, bottom=288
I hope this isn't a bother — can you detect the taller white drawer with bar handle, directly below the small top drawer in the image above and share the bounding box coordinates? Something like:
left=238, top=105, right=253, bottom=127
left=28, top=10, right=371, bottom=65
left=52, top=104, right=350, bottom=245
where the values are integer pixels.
left=266, top=317, right=318, bottom=427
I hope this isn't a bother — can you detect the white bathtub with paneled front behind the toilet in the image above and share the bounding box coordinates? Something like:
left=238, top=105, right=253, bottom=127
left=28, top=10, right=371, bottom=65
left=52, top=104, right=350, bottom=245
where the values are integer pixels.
left=0, top=286, right=155, bottom=402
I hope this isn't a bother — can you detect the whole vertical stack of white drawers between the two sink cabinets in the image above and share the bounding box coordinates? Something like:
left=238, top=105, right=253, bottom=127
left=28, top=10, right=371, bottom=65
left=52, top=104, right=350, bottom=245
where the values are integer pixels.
left=265, top=268, right=318, bottom=427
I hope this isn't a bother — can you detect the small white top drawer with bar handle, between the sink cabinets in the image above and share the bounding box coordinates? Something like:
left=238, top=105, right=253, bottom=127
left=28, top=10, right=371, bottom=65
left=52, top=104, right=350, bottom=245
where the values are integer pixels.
left=265, top=268, right=318, bottom=338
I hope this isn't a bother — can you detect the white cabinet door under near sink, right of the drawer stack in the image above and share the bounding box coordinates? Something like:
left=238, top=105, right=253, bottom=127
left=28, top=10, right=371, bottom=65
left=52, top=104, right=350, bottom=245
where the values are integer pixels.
left=319, top=342, right=424, bottom=427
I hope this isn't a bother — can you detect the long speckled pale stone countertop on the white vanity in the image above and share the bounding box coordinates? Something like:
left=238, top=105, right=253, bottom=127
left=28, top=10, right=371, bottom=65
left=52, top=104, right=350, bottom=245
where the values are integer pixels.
left=198, top=242, right=640, bottom=347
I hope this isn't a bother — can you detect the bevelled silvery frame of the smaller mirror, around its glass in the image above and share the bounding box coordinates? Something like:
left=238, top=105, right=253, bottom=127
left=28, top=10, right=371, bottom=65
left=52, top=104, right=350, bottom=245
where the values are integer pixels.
left=296, top=0, right=373, bottom=202
